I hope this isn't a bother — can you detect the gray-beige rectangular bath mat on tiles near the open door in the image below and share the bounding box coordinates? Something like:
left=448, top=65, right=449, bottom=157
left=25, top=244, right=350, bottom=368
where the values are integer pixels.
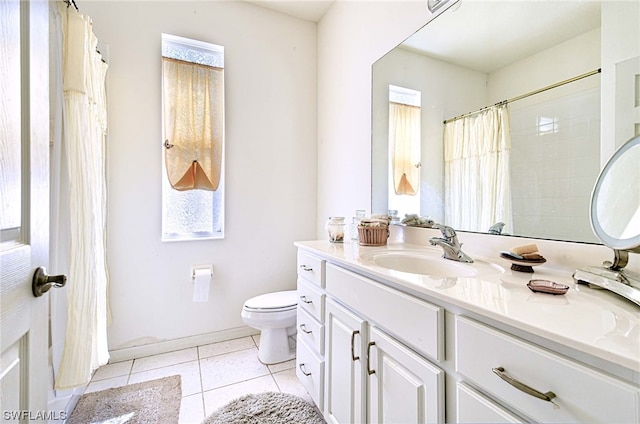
left=67, top=375, right=182, bottom=424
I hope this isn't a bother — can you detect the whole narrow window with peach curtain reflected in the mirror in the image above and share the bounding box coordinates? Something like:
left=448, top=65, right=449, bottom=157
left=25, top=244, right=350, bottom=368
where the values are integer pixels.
left=389, top=85, right=422, bottom=213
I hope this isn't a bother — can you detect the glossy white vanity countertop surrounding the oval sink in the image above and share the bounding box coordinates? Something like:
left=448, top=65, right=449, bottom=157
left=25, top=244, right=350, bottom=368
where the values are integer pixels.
left=294, top=240, right=640, bottom=379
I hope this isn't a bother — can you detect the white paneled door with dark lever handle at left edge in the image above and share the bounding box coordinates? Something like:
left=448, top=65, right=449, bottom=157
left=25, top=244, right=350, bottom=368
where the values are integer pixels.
left=0, top=0, right=52, bottom=422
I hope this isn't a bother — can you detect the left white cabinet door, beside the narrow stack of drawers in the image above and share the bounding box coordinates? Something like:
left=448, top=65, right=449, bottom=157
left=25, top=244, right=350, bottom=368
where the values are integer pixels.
left=324, top=299, right=367, bottom=423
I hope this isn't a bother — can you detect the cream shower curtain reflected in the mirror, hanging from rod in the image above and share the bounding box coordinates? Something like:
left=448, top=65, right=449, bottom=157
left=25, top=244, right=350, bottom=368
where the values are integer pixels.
left=444, top=105, right=512, bottom=232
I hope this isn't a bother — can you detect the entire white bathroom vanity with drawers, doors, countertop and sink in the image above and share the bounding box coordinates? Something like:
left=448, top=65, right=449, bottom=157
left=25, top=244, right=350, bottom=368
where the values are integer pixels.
left=295, top=240, right=640, bottom=423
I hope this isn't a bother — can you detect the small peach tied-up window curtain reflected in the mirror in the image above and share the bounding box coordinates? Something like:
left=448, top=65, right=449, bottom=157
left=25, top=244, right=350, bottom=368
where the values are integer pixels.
left=389, top=102, right=420, bottom=196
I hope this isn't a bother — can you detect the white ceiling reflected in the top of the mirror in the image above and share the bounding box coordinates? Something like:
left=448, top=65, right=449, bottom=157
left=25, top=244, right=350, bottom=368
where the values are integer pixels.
left=403, top=0, right=600, bottom=73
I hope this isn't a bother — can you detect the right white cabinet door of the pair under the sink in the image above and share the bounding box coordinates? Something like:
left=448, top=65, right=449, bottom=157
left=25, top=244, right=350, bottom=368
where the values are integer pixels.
left=366, top=327, right=444, bottom=424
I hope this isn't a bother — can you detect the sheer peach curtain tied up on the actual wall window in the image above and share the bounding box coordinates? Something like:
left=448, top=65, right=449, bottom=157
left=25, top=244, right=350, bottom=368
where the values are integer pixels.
left=162, top=57, right=224, bottom=191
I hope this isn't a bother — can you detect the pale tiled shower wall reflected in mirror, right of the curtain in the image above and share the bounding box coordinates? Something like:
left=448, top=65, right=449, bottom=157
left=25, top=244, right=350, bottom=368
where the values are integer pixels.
left=510, top=88, right=600, bottom=242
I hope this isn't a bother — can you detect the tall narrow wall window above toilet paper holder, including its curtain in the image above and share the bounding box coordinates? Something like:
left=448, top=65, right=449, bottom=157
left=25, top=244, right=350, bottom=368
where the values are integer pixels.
left=162, top=34, right=224, bottom=241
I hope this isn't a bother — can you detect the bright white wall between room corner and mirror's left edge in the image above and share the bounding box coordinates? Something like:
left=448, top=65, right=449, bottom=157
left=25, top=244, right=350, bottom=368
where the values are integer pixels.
left=316, top=0, right=430, bottom=234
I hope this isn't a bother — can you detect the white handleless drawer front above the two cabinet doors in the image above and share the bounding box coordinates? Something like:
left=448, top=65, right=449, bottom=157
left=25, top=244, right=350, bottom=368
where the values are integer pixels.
left=326, top=264, right=444, bottom=361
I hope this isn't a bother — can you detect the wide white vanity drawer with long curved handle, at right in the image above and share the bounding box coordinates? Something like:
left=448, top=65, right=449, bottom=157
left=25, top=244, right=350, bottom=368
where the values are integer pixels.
left=455, top=317, right=640, bottom=423
